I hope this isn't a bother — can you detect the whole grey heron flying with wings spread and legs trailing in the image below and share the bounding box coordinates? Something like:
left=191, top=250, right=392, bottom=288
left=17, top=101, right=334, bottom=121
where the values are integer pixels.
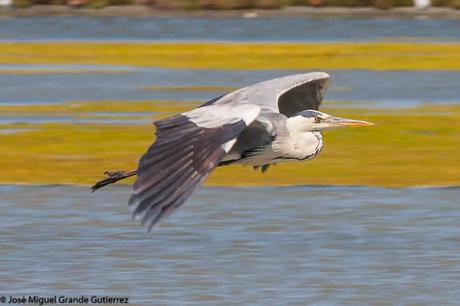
left=92, top=72, right=372, bottom=231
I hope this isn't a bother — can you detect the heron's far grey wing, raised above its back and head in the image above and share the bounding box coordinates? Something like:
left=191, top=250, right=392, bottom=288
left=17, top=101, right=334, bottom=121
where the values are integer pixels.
left=206, top=72, right=330, bottom=117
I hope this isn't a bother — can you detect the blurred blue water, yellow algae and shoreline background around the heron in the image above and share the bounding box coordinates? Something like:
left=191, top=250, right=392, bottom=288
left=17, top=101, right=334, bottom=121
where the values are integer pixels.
left=0, top=0, right=460, bottom=305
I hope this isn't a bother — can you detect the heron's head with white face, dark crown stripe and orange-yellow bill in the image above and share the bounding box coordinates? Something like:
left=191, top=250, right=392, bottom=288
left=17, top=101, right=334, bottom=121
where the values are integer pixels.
left=288, top=110, right=374, bottom=132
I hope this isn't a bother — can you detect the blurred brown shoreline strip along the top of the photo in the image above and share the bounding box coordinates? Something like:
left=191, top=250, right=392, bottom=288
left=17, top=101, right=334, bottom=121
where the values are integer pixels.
left=0, top=5, right=460, bottom=19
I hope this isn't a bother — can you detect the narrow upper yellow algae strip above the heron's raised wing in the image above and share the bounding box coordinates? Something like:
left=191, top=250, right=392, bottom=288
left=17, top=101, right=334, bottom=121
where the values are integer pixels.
left=0, top=42, right=460, bottom=70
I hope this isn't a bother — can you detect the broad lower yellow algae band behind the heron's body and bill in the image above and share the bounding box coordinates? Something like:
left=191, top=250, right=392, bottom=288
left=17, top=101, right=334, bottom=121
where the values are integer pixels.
left=0, top=104, right=460, bottom=187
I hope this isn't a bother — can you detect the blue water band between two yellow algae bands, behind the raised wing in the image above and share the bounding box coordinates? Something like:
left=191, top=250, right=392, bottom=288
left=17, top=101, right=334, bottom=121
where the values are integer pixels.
left=0, top=65, right=460, bottom=107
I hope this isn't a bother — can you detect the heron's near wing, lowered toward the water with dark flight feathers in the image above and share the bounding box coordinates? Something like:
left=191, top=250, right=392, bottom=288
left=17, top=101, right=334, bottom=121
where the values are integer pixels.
left=129, top=104, right=260, bottom=231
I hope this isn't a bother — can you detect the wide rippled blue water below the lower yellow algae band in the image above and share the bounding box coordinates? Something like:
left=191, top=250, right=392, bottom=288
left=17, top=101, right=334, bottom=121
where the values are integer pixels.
left=0, top=186, right=460, bottom=305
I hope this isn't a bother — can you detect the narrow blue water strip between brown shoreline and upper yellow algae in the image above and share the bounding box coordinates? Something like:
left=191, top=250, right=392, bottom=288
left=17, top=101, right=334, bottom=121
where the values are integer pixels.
left=0, top=16, right=460, bottom=41
